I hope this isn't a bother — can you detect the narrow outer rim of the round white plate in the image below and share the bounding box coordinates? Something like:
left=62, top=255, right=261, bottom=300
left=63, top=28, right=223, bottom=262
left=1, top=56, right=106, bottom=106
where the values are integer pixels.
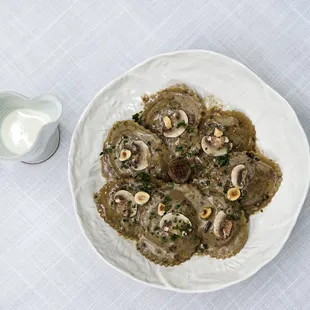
left=68, top=49, right=310, bottom=293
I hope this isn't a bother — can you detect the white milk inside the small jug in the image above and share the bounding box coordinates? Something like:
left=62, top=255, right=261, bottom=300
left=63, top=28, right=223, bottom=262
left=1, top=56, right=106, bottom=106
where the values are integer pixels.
left=0, top=109, right=51, bottom=155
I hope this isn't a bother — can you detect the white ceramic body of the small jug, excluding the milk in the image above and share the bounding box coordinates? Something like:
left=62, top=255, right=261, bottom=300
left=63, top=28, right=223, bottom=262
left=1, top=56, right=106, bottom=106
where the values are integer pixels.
left=0, top=92, right=62, bottom=164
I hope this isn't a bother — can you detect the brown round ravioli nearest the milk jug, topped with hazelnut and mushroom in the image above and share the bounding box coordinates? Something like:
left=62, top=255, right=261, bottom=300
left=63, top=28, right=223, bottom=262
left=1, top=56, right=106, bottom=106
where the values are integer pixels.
left=101, top=121, right=168, bottom=180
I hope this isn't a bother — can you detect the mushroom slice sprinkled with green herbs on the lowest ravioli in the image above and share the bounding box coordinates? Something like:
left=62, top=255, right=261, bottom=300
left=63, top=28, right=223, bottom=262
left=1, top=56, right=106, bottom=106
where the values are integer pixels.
left=159, top=213, right=192, bottom=236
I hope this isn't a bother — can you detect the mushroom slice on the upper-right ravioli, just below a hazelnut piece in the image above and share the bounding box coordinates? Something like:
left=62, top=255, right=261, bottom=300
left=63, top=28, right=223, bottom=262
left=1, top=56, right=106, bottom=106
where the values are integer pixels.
left=201, top=136, right=232, bottom=157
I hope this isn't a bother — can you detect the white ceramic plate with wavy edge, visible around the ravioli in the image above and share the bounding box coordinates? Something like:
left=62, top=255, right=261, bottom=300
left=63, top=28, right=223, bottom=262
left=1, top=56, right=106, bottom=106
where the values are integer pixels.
left=69, top=51, right=310, bottom=292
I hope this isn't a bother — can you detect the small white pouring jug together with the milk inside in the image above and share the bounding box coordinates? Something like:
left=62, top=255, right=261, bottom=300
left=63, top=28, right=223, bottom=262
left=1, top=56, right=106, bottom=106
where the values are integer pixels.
left=0, top=92, right=62, bottom=164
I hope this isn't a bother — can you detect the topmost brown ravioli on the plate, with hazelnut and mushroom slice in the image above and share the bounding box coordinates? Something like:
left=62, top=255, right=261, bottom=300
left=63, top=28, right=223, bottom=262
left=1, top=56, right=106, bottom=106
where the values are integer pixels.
left=140, top=85, right=203, bottom=157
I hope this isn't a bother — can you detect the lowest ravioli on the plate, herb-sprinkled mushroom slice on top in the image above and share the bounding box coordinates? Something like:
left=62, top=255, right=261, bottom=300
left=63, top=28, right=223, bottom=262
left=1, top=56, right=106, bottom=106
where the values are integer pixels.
left=137, top=185, right=200, bottom=266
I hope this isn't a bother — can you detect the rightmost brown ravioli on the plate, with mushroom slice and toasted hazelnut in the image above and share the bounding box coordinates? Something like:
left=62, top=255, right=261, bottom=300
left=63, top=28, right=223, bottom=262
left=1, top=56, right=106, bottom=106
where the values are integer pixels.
left=205, top=152, right=282, bottom=214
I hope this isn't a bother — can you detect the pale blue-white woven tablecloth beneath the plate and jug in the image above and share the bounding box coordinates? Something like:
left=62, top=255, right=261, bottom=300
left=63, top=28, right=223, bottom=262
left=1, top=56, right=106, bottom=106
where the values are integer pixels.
left=0, top=0, right=310, bottom=310
